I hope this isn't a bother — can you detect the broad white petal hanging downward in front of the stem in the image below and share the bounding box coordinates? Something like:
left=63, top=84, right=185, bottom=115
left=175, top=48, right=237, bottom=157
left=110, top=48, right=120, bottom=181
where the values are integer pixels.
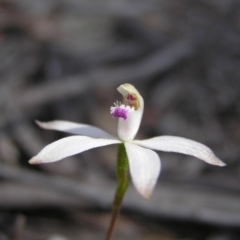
left=125, top=143, right=161, bottom=198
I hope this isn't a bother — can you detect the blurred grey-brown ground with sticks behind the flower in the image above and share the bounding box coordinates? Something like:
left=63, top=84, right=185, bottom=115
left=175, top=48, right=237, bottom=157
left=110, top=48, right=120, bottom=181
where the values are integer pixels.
left=0, top=0, right=240, bottom=240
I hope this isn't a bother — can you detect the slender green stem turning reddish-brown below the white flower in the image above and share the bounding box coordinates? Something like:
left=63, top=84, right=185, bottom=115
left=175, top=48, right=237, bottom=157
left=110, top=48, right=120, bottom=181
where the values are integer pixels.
left=106, top=144, right=129, bottom=240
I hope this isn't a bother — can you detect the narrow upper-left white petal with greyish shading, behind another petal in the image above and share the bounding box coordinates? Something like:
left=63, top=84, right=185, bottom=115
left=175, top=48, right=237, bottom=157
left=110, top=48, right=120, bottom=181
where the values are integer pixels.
left=36, top=120, right=116, bottom=139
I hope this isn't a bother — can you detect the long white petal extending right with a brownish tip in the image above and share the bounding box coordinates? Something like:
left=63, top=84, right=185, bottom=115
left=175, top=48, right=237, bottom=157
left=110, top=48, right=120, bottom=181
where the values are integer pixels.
left=133, top=136, right=226, bottom=166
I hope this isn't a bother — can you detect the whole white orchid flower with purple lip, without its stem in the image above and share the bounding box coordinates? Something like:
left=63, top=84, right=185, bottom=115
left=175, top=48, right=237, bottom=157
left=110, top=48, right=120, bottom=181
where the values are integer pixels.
left=29, top=84, right=225, bottom=198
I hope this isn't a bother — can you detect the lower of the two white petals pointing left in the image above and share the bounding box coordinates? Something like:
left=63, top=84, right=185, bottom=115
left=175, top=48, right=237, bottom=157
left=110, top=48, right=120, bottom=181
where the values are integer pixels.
left=29, top=136, right=120, bottom=164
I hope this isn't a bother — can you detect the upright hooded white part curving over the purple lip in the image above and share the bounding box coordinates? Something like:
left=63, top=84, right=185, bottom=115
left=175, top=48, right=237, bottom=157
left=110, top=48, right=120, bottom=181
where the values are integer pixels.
left=117, top=83, right=144, bottom=141
